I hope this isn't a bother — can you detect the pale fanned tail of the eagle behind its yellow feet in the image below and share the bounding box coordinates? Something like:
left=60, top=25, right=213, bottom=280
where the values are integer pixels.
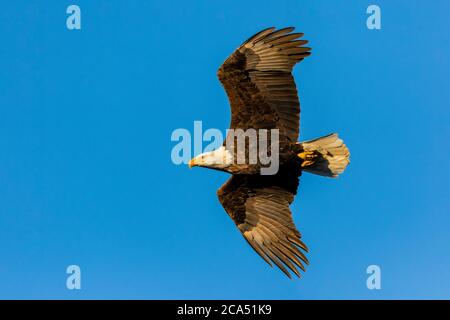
left=299, top=133, right=350, bottom=177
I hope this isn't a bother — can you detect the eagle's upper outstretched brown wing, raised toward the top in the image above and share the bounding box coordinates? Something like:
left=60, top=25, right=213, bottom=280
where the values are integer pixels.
left=217, top=27, right=310, bottom=141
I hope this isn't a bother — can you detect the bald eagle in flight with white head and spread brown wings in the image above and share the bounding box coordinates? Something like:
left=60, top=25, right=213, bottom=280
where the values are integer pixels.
left=189, top=27, right=350, bottom=278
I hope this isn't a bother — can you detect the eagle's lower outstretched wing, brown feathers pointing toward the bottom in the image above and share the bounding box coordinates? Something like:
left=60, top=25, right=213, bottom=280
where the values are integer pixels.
left=217, top=174, right=308, bottom=278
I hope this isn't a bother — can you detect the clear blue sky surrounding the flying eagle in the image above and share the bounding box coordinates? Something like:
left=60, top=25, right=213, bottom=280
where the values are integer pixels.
left=0, top=0, right=450, bottom=299
